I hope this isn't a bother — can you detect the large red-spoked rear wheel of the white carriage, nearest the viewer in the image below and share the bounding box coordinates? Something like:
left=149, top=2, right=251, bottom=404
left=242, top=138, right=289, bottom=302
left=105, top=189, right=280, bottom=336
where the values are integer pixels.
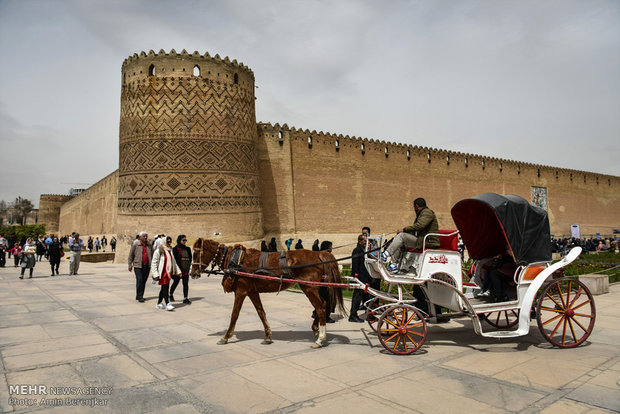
left=536, top=278, right=596, bottom=348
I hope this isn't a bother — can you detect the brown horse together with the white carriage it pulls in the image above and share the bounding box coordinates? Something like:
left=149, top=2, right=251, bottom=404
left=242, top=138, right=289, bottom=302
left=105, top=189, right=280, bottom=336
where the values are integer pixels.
left=192, top=193, right=596, bottom=354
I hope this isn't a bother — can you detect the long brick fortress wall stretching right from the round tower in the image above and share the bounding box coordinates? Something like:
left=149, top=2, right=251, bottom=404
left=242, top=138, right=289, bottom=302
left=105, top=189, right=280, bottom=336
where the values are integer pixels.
left=258, top=123, right=620, bottom=235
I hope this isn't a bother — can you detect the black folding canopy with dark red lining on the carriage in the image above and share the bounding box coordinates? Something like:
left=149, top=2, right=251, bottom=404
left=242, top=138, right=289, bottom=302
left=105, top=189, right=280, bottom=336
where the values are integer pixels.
left=452, top=193, right=551, bottom=265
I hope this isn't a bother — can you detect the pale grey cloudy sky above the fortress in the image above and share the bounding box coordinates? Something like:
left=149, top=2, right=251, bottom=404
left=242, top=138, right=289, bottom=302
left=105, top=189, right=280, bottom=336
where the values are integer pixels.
left=0, top=0, right=620, bottom=207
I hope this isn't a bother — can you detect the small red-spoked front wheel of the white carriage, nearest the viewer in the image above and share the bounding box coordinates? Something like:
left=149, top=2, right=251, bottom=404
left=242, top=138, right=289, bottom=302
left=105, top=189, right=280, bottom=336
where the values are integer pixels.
left=377, top=305, right=426, bottom=355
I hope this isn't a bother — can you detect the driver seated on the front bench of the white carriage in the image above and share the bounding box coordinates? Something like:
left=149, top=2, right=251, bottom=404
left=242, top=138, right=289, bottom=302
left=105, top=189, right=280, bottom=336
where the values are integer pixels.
left=381, top=198, right=439, bottom=272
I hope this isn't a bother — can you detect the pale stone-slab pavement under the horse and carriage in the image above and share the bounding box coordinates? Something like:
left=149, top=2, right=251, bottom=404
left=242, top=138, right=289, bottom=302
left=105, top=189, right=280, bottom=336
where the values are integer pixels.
left=0, top=260, right=620, bottom=414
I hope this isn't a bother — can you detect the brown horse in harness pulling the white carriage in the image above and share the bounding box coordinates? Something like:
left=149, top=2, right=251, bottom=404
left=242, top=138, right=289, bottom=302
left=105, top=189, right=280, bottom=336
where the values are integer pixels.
left=191, top=239, right=346, bottom=348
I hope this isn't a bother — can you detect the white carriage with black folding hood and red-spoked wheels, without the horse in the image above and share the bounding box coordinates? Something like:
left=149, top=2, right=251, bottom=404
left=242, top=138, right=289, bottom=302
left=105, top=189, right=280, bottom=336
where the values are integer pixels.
left=353, top=193, right=596, bottom=354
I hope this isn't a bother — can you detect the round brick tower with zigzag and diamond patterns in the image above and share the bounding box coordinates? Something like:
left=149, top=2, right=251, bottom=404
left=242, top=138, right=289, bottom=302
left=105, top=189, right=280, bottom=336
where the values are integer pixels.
left=117, top=50, right=263, bottom=240
